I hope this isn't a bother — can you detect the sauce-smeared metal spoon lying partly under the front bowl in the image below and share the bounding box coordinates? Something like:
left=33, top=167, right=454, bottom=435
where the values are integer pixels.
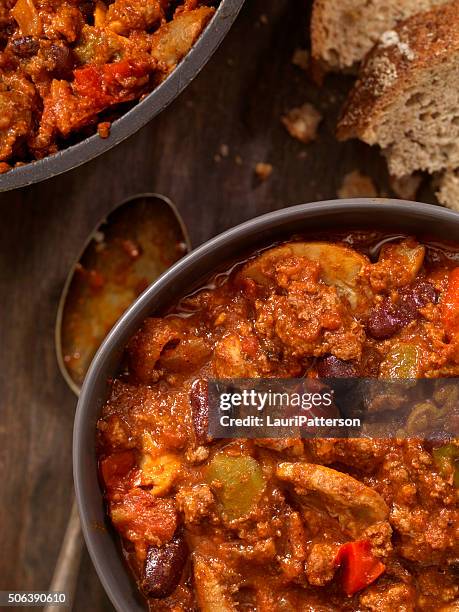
left=50, top=193, right=190, bottom=612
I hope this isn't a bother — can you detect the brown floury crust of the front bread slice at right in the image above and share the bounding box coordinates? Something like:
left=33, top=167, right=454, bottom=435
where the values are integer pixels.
left=337, top=0, right=459, bottom=144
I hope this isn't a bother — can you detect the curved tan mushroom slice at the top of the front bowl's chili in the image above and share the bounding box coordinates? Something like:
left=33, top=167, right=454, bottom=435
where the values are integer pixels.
left=241, top=242, right=370, bottom=310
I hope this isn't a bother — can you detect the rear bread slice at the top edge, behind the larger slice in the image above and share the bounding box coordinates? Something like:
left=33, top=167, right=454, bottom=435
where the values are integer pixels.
left=311, top=0, right=450, bottom=70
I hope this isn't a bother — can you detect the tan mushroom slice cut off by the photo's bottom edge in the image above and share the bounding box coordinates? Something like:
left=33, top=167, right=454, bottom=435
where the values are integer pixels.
left=193, top=554, right=236, bottom=612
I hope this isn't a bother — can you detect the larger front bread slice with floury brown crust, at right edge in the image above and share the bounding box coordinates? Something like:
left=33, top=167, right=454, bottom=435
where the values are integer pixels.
left=337, top=0, right=459, bottom=177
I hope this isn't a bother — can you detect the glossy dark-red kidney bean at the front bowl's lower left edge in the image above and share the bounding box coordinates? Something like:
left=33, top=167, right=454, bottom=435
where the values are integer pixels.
left=142, top=533, right=188, bottom=599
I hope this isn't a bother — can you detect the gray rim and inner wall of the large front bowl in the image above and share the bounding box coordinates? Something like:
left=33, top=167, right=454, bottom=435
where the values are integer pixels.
left=73, top=199, right=459, bottom=612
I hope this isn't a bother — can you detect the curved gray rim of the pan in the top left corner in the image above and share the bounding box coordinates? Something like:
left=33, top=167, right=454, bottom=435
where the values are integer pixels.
left=0, top=0, right=244, bottom=192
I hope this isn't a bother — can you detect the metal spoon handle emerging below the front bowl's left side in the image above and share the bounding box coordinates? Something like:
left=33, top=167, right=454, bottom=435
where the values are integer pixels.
left=43, top=498, right=83, bottom=612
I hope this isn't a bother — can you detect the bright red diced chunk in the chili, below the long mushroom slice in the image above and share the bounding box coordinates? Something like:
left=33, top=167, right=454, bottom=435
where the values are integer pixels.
left=335, top=540, right=386, bottom=595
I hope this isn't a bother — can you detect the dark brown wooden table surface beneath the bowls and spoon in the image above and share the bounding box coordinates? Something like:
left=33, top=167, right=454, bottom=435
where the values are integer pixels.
left=0, top=0, right=434, bottom=612
